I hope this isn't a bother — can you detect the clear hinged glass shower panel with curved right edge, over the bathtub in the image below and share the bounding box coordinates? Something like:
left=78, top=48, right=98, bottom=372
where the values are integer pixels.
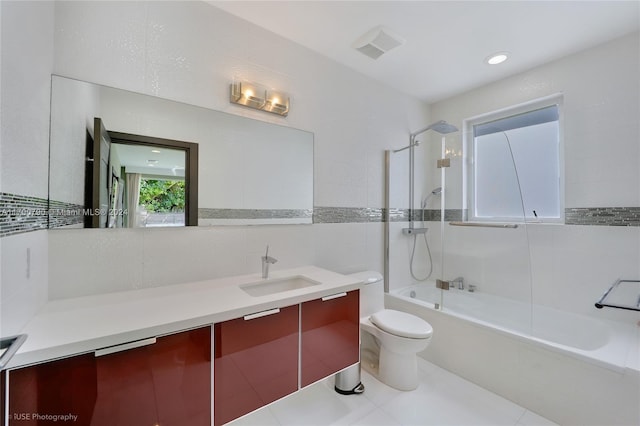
left=439, top=131, right=532, bottom=334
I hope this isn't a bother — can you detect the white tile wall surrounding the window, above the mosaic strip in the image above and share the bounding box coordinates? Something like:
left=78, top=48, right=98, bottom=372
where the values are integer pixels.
left=431, top=33, right=640, bottom=207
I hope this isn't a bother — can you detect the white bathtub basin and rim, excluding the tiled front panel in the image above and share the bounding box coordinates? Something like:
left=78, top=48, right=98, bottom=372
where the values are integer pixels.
left=390, top=282, right=640, bottom=372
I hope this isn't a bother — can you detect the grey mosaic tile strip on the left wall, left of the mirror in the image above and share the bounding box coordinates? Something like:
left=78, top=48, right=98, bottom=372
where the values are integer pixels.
left=0, top=192, right=48, bottom=237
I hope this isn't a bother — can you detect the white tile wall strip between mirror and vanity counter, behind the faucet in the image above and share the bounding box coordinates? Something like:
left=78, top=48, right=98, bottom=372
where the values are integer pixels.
left=49, top=223, right=383, bottom=300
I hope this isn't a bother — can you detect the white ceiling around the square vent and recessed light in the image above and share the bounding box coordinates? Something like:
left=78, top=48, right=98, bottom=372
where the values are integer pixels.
left=209, top=0, right=640, bottom=103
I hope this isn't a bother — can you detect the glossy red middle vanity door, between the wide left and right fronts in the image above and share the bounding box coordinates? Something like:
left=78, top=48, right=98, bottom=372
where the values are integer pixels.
left=214, top=305, right=299, bottom=425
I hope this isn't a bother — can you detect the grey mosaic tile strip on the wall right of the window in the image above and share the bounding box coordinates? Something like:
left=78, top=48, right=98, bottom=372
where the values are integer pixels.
left=564, top=207, right=640, bottom=226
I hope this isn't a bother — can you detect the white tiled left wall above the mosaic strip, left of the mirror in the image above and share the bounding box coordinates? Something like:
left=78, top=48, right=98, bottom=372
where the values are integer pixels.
left=0, top=2, right=54, bottom=198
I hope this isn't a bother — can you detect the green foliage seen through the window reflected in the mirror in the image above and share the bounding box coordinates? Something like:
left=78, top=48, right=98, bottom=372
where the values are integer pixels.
left=140, top=179, right=184, bottom=213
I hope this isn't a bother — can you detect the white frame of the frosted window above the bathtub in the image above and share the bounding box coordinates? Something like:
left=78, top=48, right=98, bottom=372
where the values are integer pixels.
left=462, top=93, right=565, bottom=224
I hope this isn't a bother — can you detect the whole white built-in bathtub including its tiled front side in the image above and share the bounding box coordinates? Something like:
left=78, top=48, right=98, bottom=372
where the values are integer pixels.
left=385, top=283, right=640, bottom=426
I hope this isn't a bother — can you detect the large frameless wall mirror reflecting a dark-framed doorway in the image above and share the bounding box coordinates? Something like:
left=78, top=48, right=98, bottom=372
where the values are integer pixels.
left=49, top=76, right=313, bottom=228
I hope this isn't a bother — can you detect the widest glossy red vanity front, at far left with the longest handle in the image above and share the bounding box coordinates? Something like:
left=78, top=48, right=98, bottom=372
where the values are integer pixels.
left=8, top=326, right=211, bottom=426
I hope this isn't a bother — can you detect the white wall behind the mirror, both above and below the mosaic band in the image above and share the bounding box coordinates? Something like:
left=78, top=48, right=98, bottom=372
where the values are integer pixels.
left=49, top=2, right=430, bottom=299
